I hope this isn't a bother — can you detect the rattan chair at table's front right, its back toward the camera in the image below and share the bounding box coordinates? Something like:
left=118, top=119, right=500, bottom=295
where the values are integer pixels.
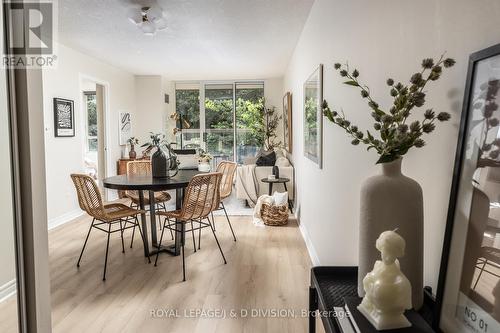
left=155, top=172, right=227, bottom=281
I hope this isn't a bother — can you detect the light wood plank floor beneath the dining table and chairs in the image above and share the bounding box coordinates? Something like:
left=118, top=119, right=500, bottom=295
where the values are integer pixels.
left=42, top=211, right=319, bottom=333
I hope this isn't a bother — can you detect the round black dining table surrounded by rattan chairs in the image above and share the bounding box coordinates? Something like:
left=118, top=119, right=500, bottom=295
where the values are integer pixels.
left=103, top=170, right=202, bottom=256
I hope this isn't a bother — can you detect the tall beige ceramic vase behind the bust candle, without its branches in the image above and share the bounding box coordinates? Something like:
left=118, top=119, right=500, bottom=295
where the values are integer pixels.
left=358, top=159, right=424, bottom=309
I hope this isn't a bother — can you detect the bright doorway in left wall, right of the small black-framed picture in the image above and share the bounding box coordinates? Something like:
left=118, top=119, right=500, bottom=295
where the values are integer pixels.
left=82, top=79, right=107, bottom=193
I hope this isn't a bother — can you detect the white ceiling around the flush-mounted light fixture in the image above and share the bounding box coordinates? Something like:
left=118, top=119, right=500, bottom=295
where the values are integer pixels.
left=58, top=0, right=314, bottom=80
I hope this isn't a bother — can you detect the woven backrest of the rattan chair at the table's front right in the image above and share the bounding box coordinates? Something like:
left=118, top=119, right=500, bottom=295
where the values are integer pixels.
left=181, top=172, right=222, bottom=220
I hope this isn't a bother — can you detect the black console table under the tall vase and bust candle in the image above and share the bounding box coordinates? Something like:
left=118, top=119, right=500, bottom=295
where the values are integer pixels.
left=309, top=266, right=434, bottom=333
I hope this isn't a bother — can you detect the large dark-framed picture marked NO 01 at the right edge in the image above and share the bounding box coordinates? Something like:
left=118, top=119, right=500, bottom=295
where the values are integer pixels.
left=435, top=44, right=500, bottom=333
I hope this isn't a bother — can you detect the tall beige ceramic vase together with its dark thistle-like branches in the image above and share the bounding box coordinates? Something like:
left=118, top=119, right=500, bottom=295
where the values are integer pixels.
left=323, top=56, right=455, bottom=309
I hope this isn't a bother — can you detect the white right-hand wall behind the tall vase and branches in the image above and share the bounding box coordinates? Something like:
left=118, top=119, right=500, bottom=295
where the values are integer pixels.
left=284, top=0, right=500, bottom=288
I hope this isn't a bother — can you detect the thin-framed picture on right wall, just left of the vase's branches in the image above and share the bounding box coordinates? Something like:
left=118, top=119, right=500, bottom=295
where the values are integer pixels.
left=304, top=64, right=323, bottom=169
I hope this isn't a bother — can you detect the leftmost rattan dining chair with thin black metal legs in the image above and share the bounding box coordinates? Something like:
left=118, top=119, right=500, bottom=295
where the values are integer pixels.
left=71, top=174, right=151, bottom=281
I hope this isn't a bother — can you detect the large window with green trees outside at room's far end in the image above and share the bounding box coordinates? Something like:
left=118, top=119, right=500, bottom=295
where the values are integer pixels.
left=174, top=82, right=265, bottom=163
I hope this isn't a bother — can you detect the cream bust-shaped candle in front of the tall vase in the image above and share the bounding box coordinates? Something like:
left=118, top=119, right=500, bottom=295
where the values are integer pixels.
left=358, top=231, right=412, bottom=330
